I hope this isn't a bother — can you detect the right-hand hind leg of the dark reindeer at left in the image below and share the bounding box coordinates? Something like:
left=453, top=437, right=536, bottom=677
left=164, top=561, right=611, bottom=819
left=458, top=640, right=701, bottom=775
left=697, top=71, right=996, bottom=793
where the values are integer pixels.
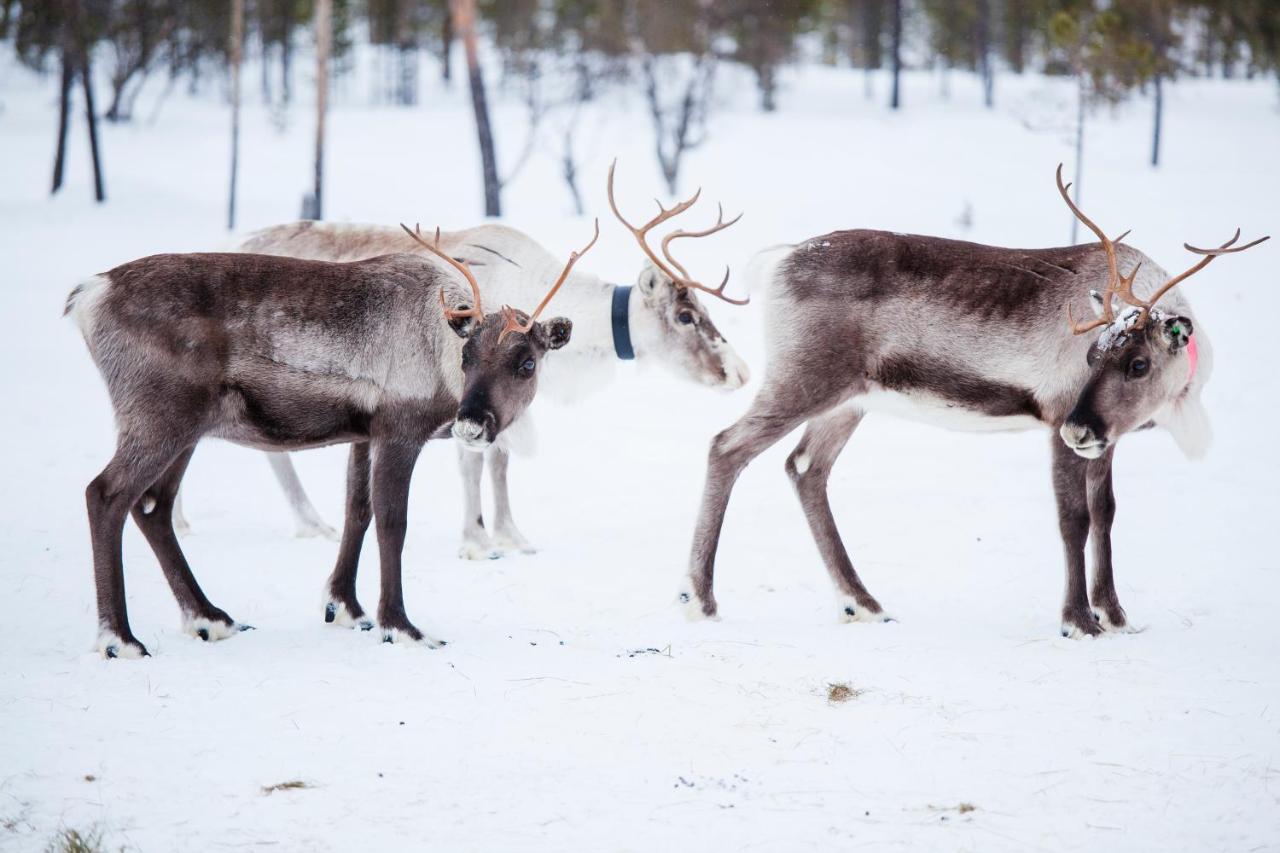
left=132, top=446, right=252, bottom=642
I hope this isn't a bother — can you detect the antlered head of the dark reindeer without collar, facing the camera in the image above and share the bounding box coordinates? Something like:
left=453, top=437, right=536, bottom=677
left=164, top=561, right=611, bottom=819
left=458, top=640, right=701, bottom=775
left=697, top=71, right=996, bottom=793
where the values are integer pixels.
left=401, top=222, right=600, bottom=452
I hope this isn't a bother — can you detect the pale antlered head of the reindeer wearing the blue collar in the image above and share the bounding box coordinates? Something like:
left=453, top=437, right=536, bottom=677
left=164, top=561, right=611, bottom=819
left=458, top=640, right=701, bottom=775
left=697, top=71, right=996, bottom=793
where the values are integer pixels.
left=608, top=161, right=750, bottom=391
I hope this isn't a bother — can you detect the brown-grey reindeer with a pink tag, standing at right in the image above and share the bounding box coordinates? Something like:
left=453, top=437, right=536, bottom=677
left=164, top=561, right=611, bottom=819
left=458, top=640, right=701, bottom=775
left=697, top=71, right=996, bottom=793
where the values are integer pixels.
left=680, top=165, right=1266, bottom=637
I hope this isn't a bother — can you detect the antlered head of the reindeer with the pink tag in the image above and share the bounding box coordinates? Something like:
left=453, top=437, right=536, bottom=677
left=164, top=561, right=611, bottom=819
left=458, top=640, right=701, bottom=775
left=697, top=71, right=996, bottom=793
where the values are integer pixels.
left=1057, top=165, right=1268, bottom=459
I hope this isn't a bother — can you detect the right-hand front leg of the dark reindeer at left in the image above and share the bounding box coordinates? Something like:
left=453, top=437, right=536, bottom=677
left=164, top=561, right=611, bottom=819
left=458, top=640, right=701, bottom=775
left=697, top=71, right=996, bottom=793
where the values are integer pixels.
left=372, top=441, right=444, bottom=648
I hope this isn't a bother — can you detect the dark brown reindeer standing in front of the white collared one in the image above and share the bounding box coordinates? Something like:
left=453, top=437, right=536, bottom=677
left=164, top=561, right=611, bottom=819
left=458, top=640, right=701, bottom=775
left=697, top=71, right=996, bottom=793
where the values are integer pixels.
left=65, top=223, right=599, bottom=657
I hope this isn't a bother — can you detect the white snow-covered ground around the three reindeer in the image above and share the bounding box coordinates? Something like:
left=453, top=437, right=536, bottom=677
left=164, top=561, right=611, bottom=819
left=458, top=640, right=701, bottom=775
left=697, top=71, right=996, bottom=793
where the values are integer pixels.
left=0, top=53, right=1280, bottom=850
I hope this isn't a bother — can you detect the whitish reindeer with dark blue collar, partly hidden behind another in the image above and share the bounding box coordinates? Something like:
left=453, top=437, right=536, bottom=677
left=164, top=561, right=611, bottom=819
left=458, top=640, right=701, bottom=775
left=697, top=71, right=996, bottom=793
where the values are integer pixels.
left=202, top=163, right=748, bottom=560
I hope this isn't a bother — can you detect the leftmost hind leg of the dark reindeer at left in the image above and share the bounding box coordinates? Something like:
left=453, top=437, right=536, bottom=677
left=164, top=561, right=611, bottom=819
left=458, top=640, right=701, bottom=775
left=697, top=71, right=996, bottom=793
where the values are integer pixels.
left=84, top=432, right=196, bottom=657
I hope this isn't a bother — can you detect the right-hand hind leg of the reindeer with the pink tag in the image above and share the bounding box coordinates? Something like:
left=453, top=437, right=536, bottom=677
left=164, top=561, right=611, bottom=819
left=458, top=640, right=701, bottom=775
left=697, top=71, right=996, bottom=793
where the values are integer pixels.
left=786, top=406, right=892, bottom=622
